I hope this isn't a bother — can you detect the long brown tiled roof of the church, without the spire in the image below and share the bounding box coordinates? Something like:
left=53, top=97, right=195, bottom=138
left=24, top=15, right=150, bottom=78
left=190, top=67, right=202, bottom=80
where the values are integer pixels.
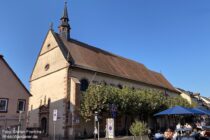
left=54, top=32, right=178, bottom=93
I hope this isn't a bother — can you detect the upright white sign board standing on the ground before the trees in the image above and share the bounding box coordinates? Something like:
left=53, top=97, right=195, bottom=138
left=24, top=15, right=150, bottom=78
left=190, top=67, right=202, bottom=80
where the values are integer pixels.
left=106, top=118, right=114, bottom=139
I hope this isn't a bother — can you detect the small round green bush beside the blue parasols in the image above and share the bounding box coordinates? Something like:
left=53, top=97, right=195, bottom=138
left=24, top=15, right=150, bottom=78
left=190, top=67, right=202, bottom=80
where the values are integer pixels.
left=129, top=120, right=148, bottom=140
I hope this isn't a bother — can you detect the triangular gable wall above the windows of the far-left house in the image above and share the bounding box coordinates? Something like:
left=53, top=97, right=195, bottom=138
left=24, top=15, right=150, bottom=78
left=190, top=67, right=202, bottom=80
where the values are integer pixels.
left=0, top=58, right=31, bottom=98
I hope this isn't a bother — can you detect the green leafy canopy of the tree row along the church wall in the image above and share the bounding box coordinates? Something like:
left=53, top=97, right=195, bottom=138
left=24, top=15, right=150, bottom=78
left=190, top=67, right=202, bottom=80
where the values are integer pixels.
left=81, top=85, right=192, bottom=121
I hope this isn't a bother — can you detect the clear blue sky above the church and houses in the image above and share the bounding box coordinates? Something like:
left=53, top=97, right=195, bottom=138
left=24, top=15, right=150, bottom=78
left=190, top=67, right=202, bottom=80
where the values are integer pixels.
left=0, top=0, right=210, bottom=97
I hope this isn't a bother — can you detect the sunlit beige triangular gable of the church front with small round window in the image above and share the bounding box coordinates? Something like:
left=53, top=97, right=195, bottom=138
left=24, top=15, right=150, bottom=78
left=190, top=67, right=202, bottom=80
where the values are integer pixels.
left=30, top=30, right=69, bottom=81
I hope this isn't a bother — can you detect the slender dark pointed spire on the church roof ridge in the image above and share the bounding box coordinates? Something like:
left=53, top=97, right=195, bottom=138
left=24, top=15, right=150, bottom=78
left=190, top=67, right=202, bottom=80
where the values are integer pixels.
left=59, top=2, right=71, bottom=40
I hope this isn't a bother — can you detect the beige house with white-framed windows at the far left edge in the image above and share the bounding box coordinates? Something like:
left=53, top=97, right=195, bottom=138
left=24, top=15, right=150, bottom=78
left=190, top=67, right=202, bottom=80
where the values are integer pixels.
left=0, top=55, right=30, bottom=132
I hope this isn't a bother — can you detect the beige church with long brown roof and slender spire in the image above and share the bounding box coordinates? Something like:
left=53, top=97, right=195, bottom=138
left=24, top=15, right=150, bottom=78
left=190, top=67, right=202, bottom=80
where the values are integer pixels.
left=29, top=2, right=179, bottom=139
